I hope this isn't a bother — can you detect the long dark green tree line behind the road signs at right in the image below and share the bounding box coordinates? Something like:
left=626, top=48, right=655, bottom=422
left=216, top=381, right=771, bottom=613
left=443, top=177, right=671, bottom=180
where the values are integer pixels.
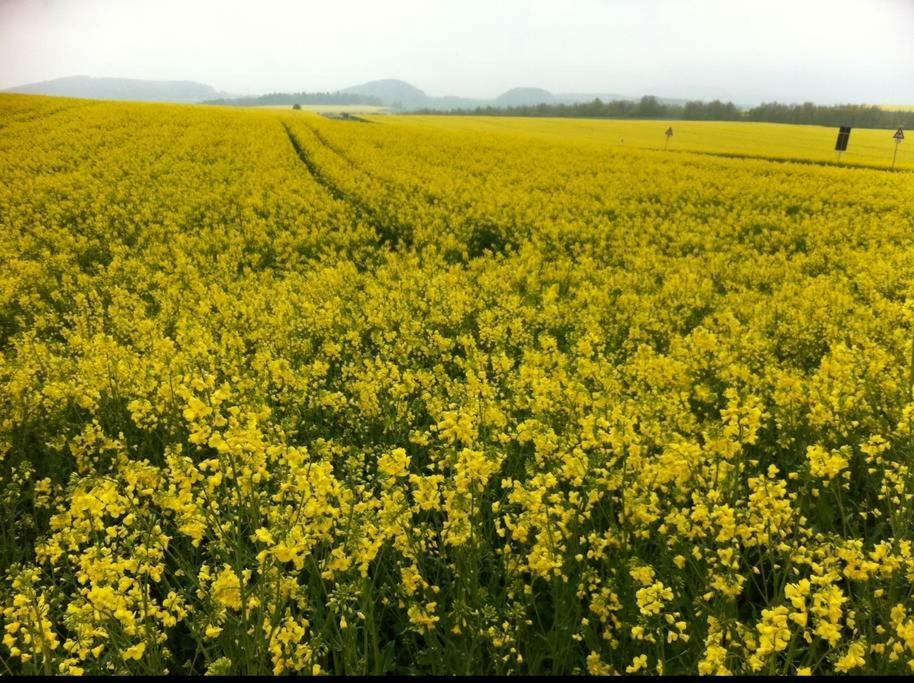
left=413, top=95, right=914, bottom=129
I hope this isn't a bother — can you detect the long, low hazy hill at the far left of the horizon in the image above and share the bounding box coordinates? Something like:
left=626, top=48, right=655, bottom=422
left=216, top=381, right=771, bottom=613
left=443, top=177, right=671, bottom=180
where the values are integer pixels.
left=5, top=76, right=223, bottom=102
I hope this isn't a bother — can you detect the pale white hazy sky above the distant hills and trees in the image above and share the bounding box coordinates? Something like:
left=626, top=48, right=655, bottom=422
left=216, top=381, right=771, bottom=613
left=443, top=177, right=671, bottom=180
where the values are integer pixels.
left=0, top=0, right=914, bottom=104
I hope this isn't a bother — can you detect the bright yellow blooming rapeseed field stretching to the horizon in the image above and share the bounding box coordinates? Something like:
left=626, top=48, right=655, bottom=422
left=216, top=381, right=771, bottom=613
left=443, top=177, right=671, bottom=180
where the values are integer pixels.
left=0, top=95, right=914, bottom=674
